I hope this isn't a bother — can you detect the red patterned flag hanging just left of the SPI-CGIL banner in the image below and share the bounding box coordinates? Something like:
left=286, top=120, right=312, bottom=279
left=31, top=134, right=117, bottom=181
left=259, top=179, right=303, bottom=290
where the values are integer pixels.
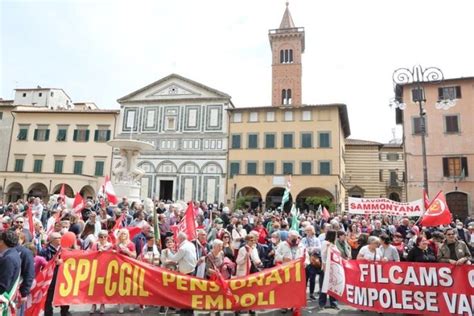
left=25, top=257, right=56, bottom=316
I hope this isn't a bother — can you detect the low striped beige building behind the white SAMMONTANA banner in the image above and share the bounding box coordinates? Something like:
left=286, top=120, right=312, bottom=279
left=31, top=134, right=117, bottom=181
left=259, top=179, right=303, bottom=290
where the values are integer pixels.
left=344, top=139, right=406, bottom=202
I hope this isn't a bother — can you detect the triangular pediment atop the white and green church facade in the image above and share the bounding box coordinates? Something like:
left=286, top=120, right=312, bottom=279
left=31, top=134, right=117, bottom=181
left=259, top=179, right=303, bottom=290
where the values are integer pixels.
left=117, top=74, right=230, bottom=103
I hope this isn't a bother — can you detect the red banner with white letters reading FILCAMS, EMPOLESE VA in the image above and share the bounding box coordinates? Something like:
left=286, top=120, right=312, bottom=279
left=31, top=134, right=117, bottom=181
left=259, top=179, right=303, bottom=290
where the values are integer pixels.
left=323, top=252, right=474, bottom=315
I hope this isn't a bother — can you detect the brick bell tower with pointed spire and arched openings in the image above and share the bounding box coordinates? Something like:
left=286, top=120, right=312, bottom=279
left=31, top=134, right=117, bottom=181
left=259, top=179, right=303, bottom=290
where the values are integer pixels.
left=268, top=2, right=304, bottom=106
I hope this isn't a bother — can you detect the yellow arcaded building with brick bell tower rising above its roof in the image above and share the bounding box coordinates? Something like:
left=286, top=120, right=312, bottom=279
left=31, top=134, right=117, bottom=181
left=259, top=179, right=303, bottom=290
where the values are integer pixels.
left=226, top=3, right=350, bottom=209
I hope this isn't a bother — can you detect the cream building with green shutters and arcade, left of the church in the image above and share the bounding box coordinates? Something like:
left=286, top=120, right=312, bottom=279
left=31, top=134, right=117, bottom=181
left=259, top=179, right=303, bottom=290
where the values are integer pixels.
left=0, top=99, right=119, bottom=202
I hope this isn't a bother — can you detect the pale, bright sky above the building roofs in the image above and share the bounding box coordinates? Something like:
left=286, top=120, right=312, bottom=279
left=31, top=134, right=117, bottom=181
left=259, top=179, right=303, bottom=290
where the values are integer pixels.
left=0, top=0, right=474, bottom=142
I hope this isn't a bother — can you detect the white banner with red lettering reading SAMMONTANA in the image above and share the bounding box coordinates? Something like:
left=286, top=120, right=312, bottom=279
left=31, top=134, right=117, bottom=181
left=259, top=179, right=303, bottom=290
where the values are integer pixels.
left=349, top=197, right=423, bottom=217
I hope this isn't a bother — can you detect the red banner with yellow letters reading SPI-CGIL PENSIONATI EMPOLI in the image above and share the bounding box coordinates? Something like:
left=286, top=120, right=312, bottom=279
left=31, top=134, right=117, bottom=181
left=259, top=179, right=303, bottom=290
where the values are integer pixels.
left=54, top=251, right=306, bottom=310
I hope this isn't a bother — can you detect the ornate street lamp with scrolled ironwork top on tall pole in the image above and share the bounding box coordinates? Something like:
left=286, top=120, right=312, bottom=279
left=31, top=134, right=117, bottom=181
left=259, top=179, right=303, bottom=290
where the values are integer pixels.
left=390, top=65, right=456, bottom=194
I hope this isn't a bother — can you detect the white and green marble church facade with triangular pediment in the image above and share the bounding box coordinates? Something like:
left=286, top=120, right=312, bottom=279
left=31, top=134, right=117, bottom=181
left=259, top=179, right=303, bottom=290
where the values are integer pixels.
left=113, top=74, right=233, bottom=203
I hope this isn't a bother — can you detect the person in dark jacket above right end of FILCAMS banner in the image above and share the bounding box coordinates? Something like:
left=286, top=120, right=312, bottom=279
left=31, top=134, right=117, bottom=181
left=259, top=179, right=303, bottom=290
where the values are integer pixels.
left=438, top=228, right=472, bottom=265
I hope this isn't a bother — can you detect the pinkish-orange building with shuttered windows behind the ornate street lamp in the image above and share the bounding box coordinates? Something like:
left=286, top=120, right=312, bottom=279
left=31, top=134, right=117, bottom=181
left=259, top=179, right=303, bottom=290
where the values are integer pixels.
left=396, top=77, right=474, bottom=218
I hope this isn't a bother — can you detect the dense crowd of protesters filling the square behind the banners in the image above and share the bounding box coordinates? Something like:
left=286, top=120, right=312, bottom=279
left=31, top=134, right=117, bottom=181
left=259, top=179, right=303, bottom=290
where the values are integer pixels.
left=0, top=198, right=474, bottom=316
